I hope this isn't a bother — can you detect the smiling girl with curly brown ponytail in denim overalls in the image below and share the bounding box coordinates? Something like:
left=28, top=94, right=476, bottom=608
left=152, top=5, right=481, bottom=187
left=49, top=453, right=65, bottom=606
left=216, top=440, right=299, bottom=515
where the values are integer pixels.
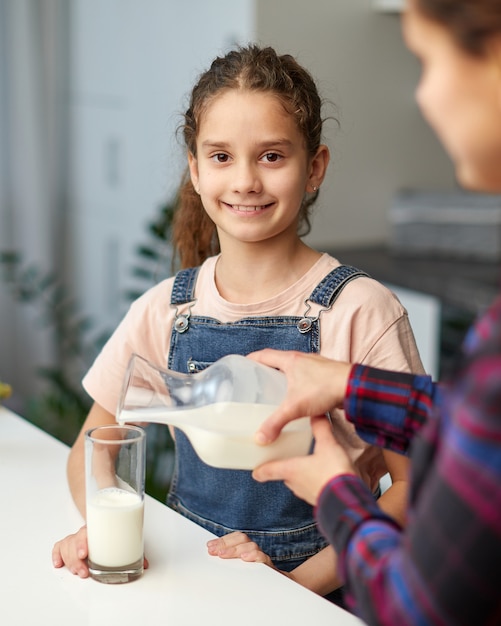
left=54, top=46, right=423, bottom=595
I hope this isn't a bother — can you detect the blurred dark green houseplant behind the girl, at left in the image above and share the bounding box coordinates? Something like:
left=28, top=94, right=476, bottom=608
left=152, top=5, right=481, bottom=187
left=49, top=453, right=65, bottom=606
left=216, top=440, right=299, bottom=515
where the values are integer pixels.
left=0, top=199, right=177, bottom=500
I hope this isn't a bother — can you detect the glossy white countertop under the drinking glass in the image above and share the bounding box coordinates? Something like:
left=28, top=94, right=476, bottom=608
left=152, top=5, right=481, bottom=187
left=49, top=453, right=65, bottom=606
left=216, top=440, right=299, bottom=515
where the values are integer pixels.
left=0, top=407, right=362, bottom=626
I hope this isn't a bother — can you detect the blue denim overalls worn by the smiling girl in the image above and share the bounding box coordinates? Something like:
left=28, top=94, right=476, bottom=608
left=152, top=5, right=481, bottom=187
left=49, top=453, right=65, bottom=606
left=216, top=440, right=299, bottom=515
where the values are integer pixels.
left=167, top=266, right=367, bottom=571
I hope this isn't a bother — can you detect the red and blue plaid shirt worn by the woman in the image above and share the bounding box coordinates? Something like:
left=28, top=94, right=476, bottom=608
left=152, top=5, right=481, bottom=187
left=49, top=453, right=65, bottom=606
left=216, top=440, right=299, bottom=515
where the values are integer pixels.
left=317, top=298, right=501, bottom=626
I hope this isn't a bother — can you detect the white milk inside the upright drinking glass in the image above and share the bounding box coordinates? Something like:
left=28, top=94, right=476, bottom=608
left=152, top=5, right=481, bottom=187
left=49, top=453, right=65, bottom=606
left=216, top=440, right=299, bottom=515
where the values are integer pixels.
left=87, top=487, right=144, bottom=567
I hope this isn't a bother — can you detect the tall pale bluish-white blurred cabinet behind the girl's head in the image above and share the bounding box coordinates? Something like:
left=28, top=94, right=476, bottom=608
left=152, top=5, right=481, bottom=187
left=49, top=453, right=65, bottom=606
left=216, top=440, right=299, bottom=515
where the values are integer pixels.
left=69, top=0, right=255, bottom=329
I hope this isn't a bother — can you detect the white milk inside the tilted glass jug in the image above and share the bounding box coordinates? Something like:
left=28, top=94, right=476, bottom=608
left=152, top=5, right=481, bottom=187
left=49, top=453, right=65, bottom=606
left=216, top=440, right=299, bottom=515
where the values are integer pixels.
left=118, top=402, right=311, bottom=470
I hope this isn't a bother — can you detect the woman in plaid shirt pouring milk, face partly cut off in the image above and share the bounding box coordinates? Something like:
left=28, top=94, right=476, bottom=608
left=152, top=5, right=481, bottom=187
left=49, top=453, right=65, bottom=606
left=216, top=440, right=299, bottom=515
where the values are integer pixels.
left=246, top=0, right=501, bottom=626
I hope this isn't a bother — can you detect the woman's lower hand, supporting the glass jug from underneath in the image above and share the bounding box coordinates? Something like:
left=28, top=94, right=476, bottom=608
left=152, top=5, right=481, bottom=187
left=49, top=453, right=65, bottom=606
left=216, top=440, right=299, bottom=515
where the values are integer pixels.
left=252, top=417, right=357, bottom=505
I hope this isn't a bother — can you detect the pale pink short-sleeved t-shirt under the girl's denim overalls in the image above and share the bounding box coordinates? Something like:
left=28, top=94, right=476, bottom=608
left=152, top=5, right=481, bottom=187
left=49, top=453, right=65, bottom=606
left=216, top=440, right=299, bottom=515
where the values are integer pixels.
left=83, top=254, right=424, bottom=482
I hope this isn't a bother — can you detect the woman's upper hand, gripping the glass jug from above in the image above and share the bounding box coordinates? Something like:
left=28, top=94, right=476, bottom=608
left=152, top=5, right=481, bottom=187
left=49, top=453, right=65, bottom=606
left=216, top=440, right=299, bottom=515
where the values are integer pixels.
left=248, top=348, right=352, bottom=445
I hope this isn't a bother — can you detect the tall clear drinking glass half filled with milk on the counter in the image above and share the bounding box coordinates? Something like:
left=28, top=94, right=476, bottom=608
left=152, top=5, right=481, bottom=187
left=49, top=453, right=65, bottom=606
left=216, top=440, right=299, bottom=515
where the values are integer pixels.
left=85, top=425, right=146, bottom=583
